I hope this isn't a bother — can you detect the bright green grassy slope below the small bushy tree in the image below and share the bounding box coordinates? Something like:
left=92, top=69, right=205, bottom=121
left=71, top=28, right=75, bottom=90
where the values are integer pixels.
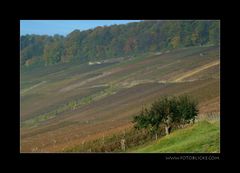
left=130, top=121, right=220, bottom=153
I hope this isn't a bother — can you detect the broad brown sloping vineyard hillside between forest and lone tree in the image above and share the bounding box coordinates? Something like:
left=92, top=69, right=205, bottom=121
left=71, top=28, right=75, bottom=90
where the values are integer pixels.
left=20, top=46, right=220, bottom=152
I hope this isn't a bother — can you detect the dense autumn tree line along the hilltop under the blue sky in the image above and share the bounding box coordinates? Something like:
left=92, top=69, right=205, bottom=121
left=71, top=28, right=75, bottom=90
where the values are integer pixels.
left=20, top=20, right=220, bottom=65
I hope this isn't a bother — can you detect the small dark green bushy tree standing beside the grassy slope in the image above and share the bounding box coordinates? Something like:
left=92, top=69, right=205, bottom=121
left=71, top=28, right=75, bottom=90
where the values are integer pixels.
left=133, top=96, right=198, bottom=135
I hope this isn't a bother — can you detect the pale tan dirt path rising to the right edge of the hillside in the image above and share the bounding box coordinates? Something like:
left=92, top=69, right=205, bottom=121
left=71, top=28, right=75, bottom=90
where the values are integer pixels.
left=174, top=60, right=220, bottom=82
